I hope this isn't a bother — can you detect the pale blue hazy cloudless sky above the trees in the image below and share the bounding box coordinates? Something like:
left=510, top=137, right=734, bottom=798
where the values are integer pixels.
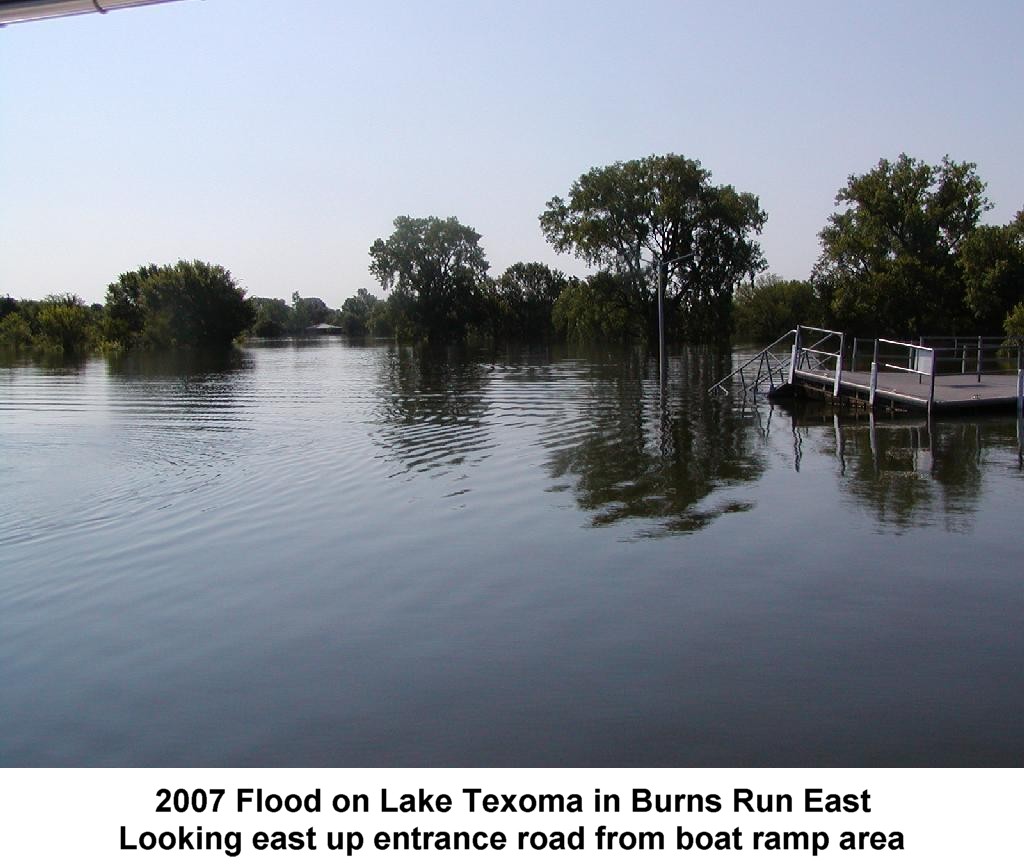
left=0, top=0, right=1024, bottom=306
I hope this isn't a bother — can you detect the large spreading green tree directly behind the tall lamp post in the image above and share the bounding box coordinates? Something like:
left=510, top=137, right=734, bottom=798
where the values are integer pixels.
left=541, top=154, right=767, bottom=337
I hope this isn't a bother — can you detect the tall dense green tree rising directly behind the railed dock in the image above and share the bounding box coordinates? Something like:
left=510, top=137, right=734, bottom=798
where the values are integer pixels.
left=812, top=154, right=991, bottom=337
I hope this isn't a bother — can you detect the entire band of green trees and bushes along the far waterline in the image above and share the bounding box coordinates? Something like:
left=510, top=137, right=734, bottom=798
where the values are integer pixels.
left=6, top=154, right=1024, bottom=355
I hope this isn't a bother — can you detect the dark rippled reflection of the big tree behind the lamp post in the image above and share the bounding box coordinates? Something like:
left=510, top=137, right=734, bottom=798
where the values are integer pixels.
left=545, top=348, right=766, bottom=536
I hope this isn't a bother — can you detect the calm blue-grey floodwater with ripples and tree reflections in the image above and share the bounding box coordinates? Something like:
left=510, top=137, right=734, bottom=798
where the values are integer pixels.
left=0, top=338, right=1024, bottom=767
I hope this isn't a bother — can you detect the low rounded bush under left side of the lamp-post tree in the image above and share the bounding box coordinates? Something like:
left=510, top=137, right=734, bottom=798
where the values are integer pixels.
left=551, top=271, right=644, bottom=342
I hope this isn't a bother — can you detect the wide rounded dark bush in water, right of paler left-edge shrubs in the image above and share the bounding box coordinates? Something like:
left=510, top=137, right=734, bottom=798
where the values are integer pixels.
left=106, top=261, right=254, bottom=347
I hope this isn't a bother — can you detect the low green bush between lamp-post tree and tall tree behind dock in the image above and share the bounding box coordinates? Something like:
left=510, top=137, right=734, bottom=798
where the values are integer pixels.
left=732, top=274, right=820, bottom=344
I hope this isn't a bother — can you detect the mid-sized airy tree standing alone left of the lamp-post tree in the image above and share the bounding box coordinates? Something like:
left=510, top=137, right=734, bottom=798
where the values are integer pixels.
left=370, top=217, right=489, bottom=342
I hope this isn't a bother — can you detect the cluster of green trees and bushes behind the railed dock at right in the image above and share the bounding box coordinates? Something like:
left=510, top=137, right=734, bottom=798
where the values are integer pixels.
left=735, top=155, right=1024, bottom=340
